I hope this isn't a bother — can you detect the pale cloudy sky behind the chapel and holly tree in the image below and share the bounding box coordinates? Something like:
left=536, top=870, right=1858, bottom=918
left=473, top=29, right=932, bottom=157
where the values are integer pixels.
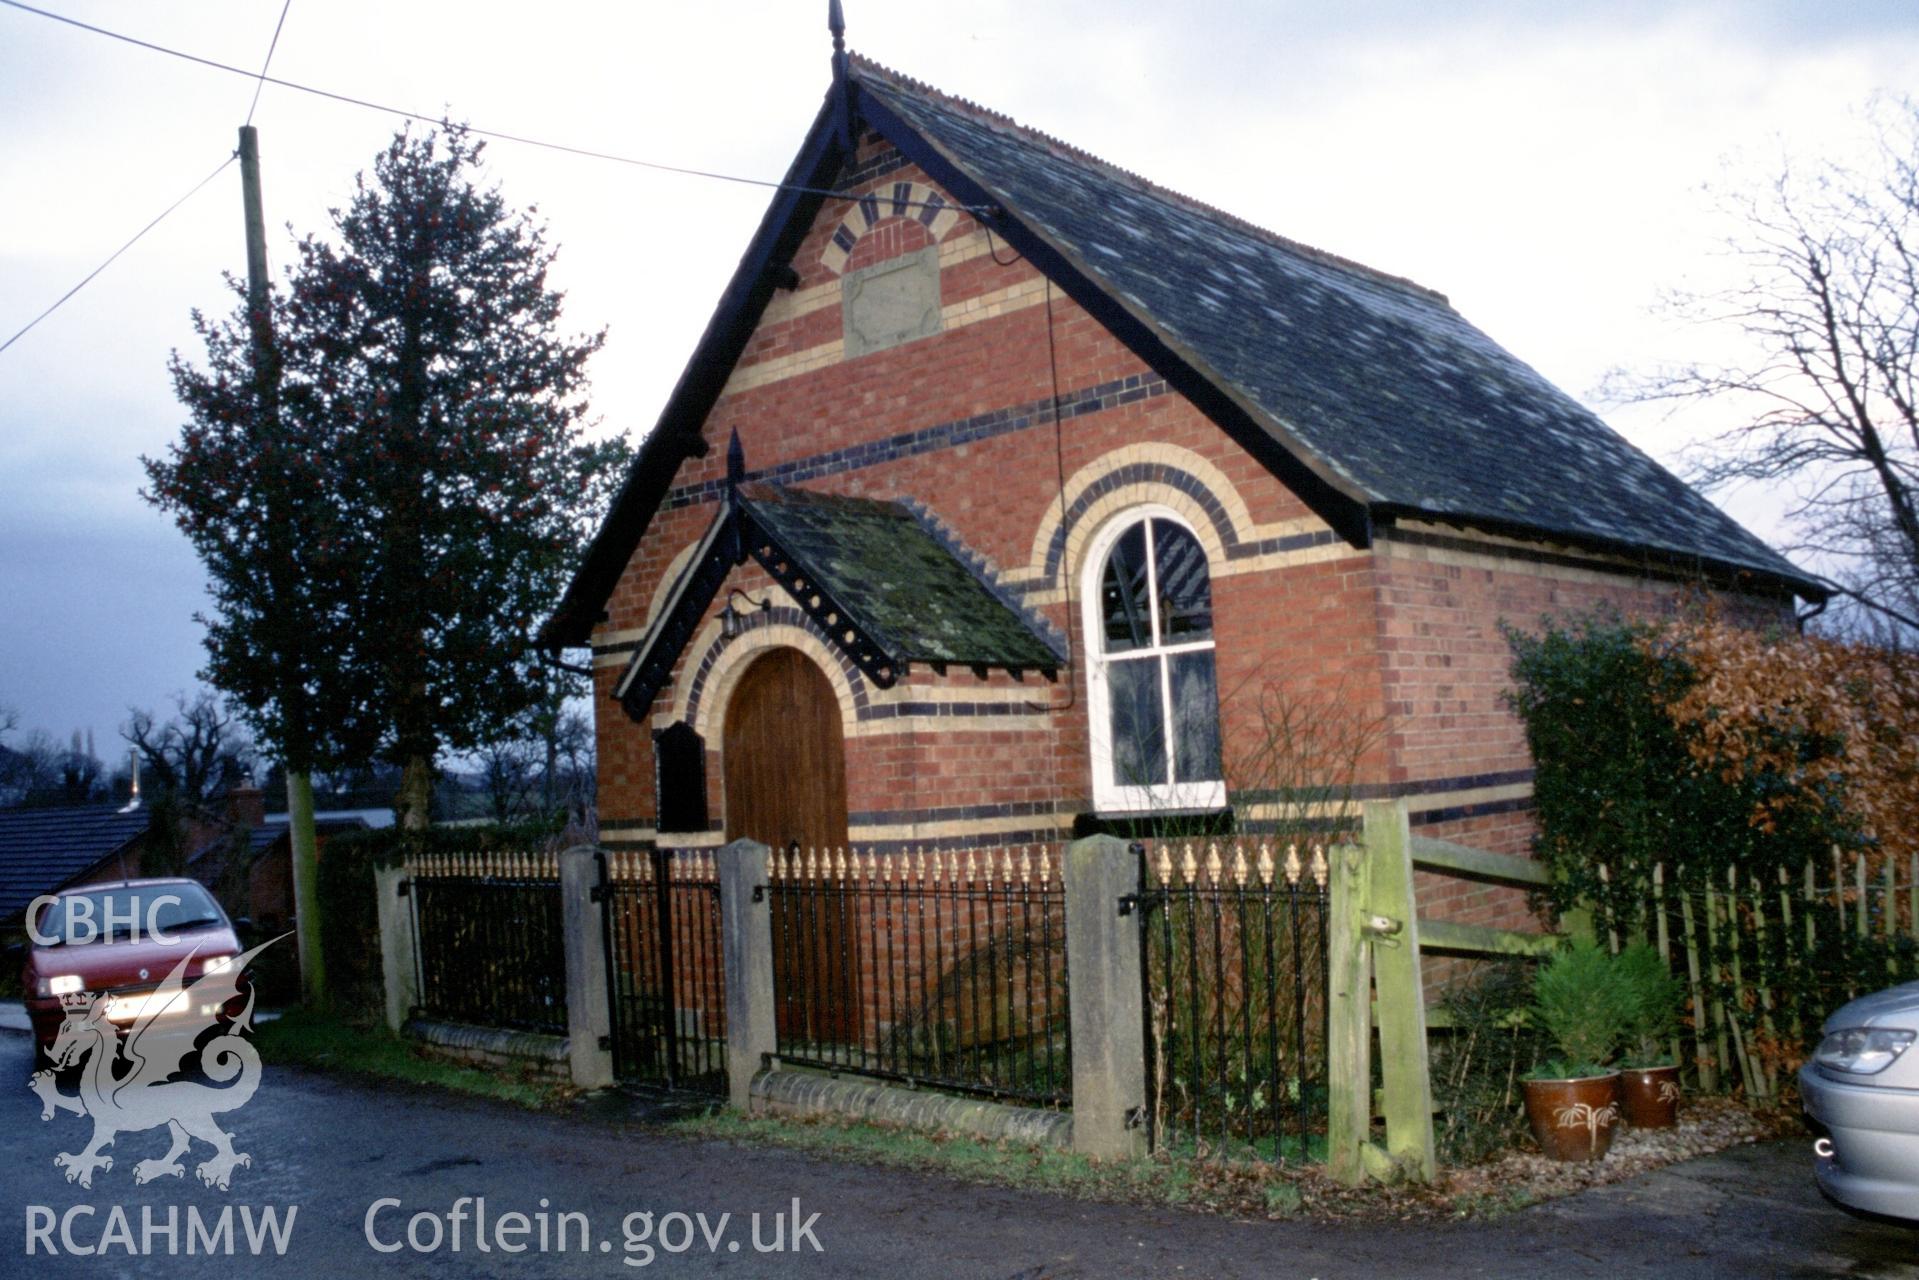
left=0, top=0, right=1919, bottom=754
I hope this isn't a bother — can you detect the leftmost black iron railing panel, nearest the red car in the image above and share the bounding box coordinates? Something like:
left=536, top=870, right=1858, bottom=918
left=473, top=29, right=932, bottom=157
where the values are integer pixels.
left=409, top=854, right=566, bottom=1036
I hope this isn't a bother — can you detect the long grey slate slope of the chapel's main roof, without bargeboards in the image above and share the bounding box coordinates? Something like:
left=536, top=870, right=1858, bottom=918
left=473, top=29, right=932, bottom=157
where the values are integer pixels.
left=854, top=59, right=1810, bottom=598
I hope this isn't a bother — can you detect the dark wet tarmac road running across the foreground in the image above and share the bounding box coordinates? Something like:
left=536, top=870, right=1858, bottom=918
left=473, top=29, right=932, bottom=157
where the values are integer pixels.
left=0, top=1031, right=1919, bottom=1280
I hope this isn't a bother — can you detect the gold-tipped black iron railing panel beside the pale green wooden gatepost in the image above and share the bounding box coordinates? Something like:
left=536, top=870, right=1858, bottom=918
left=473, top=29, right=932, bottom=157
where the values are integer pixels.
left=1132, top=844, right=1328, bottom=1161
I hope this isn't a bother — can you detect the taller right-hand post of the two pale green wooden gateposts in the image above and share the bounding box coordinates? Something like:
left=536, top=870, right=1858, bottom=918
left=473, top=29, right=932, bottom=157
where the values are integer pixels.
left=1364, top=800, right=1437, bottom=1182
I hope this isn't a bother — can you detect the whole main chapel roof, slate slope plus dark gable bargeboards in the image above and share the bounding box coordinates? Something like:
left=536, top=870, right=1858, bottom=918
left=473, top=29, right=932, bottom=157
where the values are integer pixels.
left=541, top=58, right=1829, bottom=645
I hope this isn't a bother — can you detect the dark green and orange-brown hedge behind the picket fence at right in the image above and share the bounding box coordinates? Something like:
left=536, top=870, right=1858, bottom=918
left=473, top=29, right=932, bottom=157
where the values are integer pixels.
left=1504, top=608, right=1919, bottom=1096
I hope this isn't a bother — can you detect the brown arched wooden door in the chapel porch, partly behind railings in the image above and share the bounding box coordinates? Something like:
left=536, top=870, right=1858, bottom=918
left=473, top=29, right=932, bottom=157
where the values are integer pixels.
left=720, top=649, right=860, bottom=1042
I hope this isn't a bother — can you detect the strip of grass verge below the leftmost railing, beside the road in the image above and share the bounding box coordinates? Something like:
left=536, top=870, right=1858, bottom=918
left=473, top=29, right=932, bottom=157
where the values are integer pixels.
left=253, top=1007, right=578, bottom=1107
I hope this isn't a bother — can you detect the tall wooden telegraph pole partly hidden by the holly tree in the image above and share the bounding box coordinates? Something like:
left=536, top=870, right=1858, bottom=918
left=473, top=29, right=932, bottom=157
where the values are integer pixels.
left=240, top=125, right=326, bottom=1006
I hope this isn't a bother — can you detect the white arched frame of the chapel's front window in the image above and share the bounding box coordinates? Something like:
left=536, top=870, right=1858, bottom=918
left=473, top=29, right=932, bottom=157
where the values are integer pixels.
left=1080, top=503, right=1226, bottom=812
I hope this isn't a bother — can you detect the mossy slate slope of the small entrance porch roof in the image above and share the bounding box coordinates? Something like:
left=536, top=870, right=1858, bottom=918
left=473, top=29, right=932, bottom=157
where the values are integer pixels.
left=739, top=484, right=1063, bottom=670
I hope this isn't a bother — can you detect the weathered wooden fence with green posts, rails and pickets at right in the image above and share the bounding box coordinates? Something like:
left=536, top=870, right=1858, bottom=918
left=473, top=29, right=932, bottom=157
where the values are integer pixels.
left=1326, top=802, right=1919, bottom=1182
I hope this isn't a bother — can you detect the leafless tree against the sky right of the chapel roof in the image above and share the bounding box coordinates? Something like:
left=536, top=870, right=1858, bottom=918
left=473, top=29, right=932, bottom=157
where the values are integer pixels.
left=1604, top=100, right=1919, bottom=631
